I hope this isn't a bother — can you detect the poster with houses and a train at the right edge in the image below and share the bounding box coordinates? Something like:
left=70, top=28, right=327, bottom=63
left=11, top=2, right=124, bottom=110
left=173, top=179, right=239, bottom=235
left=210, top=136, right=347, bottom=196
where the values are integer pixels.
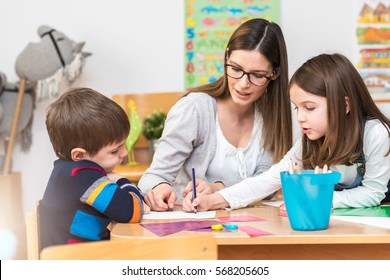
left=356, top=0, right=390, bottom=102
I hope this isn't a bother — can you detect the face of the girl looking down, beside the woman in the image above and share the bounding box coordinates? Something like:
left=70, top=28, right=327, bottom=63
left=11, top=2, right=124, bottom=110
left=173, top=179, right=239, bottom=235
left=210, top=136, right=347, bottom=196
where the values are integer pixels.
left=290, top=84, right=328, bottom=140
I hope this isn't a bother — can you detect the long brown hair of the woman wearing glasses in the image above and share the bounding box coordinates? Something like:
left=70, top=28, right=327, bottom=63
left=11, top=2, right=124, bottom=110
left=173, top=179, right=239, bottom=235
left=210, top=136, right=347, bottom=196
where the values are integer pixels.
left=190, top=18, right=292, bottom=162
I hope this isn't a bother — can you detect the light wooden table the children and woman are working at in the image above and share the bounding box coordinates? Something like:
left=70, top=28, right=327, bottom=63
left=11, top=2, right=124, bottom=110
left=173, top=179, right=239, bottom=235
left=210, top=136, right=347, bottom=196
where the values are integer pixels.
left=111, top=202, right=390, bottom=260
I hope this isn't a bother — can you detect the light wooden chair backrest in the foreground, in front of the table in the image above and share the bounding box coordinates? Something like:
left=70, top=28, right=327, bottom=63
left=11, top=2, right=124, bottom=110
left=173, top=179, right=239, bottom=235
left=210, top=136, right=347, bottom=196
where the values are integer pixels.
left=41, top=235, right=217, bottom=260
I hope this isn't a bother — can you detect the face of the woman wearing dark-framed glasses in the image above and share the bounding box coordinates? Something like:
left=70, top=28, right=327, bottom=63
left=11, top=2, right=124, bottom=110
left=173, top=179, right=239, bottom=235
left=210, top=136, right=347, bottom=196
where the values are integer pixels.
left=226, top=50, right=272, bottom=105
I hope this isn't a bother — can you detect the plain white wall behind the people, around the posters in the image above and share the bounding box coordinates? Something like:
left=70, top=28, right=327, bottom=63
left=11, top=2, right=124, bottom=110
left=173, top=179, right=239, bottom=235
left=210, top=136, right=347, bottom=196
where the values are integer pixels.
left=0, top=0, right=390, bottom=215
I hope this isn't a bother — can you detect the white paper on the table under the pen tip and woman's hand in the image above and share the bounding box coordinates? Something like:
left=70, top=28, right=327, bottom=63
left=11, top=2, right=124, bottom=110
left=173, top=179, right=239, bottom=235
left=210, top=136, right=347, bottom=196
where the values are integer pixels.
left=143, top=211, right=216, bottom=220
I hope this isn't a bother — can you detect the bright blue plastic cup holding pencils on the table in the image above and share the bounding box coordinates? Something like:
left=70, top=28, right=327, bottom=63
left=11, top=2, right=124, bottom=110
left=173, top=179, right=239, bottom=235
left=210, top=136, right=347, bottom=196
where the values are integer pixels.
left=280, top=170, right=341, bottom=230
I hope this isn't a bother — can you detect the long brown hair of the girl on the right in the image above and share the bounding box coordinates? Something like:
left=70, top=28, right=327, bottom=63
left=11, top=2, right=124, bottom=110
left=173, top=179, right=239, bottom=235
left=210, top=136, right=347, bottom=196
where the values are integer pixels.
left=290, top=54, right=390, bottom=168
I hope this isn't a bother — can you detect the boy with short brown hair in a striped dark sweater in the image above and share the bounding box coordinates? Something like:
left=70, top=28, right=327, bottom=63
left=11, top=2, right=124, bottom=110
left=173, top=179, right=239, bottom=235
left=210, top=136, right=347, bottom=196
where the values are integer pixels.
left=39, top=88, right=150, bottom=248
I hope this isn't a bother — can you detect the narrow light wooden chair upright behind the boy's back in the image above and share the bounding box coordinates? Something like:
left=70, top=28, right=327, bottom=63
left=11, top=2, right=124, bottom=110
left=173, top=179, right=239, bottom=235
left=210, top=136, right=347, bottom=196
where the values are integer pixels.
left=26, top=201, right=41, bottom=260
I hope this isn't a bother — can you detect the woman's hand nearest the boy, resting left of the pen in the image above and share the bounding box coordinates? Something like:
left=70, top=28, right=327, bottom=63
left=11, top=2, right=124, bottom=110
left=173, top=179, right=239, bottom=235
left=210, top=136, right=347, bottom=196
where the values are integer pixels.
left=145, top=183, right=177, bottom=211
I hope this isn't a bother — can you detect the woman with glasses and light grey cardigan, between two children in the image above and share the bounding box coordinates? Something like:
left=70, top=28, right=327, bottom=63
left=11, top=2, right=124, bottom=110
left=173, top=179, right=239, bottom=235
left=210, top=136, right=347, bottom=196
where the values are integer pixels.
left=139, top=19, right=292, bottom=211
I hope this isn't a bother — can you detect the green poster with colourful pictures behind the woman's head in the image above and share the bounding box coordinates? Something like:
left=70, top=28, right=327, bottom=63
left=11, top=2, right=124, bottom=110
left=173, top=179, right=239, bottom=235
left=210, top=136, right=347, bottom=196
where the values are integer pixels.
left=185, top=0, right=280, bottom=90
